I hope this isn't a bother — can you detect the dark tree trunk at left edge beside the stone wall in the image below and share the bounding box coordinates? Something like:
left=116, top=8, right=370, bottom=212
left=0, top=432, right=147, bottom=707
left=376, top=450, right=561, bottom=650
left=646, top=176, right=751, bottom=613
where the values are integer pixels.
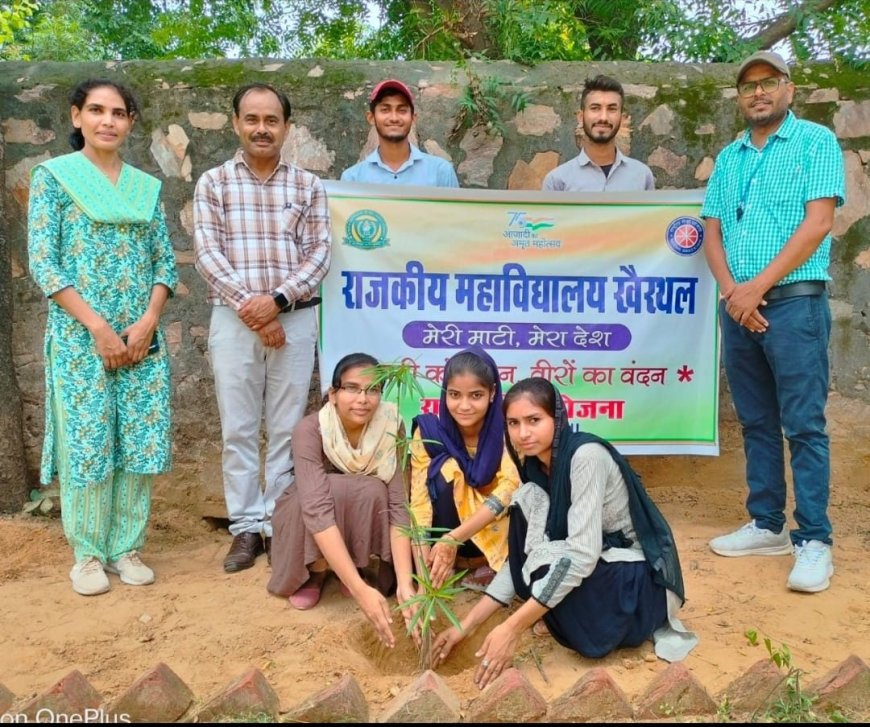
left=0, top=135, right=28, bottom=512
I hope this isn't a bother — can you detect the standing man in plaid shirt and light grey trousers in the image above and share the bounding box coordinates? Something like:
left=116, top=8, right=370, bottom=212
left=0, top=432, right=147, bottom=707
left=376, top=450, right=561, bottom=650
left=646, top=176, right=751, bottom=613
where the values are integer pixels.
left=193, top=83, right=331, bottom=573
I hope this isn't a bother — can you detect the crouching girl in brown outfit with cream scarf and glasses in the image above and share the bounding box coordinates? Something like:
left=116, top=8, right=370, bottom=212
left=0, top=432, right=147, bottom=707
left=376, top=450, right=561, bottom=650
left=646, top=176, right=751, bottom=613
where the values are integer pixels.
left=267, top=353, right=414, bottom=646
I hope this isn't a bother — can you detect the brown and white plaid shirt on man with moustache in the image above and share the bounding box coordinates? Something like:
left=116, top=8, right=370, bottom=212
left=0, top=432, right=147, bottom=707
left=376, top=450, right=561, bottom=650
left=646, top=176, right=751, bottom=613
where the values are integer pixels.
left=193, top=149, right=332, bottom=310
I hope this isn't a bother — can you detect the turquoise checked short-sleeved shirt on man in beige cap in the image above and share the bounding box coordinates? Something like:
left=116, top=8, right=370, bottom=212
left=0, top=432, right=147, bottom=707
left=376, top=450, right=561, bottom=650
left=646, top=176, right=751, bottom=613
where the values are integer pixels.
left=701, top=111, right=846, bottom=285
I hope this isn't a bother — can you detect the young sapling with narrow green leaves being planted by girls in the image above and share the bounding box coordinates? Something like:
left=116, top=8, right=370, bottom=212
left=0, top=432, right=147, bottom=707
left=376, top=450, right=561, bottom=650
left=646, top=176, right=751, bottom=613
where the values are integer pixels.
left=368, top=362, right=466, bottom=669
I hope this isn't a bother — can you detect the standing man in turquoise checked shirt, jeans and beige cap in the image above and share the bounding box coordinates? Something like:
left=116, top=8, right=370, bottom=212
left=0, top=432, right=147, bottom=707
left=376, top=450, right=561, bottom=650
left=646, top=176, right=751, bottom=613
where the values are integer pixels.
left=701, top=51, right=845, bottom=593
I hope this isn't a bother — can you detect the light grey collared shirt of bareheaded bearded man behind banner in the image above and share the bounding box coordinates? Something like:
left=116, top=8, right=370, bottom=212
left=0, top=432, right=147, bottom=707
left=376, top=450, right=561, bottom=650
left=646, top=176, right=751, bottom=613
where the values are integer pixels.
left=541, top=149, right=656, bottom=192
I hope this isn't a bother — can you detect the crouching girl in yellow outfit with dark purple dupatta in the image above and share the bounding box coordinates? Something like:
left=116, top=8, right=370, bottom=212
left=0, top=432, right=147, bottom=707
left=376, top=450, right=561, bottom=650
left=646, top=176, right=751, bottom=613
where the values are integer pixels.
left=411, top=347, right=519, bottom=590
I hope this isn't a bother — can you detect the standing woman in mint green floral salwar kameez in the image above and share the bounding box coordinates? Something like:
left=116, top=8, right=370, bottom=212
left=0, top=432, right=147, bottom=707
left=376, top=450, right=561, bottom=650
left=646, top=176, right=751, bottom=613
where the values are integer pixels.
left=28, top=81, right=177, bottom=595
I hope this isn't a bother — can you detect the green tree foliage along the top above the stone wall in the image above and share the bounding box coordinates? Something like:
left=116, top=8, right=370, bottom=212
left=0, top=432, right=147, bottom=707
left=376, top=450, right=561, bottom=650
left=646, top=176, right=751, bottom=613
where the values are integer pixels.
left=0, top=0, right=870, bottom=64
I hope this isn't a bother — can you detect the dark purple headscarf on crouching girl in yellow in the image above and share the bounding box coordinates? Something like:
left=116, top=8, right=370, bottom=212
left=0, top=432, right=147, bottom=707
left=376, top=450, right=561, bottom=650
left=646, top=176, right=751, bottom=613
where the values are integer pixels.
left=412, top=346, right=504, bottom=502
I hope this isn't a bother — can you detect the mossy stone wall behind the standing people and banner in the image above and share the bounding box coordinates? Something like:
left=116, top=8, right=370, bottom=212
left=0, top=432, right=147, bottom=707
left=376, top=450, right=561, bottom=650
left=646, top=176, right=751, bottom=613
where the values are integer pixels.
left=0, top=60, right=870, bottom=511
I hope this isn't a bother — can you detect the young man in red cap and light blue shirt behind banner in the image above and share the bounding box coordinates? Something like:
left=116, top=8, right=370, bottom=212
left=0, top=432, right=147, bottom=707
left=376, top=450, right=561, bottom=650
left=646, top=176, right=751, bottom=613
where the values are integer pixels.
left=341, top=79, right=459, bottom=187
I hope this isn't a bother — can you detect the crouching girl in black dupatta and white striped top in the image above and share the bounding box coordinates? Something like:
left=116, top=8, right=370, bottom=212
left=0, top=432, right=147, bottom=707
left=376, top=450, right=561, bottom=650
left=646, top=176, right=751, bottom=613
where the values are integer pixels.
left=433, top=378, right=697, bottom=689
